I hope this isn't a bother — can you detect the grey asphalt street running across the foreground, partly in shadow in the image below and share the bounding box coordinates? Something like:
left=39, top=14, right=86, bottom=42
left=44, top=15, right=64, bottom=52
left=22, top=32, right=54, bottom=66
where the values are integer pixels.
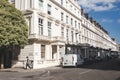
left=0, top=59, right=120, bottom=80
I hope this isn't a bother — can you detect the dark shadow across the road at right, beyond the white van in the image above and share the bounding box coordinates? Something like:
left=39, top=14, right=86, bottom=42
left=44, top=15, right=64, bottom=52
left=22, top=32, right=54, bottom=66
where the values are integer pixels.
left=80, top=59, right=120, bottom=71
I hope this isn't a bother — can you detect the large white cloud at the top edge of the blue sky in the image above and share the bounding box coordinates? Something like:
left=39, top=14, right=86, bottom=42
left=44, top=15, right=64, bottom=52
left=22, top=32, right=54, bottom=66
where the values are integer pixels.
left=78, top=0, right=120, bottom=11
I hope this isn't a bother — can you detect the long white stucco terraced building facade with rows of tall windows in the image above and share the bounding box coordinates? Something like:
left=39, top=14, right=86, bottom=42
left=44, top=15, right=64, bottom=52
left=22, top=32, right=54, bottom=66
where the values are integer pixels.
left=10, top=0, right=117, bottom=69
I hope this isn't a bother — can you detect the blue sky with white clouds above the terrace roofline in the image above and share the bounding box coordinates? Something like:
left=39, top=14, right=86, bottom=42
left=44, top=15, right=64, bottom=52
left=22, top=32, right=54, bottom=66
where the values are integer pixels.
left=78, top=0, right=120, bottom=44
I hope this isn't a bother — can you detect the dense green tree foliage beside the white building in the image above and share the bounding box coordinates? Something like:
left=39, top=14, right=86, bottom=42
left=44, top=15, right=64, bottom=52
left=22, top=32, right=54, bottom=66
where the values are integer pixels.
left=0, top=0, right=28, bottom=47
